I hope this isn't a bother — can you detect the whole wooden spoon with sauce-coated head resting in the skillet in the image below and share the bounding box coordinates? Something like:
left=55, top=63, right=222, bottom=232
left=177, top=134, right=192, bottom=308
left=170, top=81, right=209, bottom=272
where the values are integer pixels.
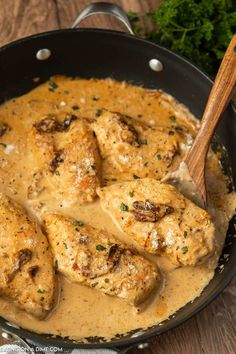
left=163, top=34, right=236, bottom=208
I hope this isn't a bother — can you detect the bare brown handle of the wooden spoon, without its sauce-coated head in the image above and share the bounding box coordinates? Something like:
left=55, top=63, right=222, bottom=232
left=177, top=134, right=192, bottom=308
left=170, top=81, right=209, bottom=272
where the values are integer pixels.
left=185, top=34, right=236, bottom=174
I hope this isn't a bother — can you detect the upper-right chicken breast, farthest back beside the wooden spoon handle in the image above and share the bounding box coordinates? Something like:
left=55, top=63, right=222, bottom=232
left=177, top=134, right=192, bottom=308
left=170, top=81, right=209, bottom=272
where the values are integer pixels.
left=92, top=111, right=179, bottom=180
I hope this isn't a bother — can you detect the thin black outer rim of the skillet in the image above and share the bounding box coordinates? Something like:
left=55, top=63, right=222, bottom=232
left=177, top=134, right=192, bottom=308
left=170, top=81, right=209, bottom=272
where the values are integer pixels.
left=0, top=28, right=236, bottom=350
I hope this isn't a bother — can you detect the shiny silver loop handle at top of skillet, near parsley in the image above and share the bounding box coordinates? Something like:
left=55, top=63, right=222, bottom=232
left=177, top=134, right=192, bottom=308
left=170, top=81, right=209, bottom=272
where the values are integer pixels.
left=71, top=2, right=134, bottom=34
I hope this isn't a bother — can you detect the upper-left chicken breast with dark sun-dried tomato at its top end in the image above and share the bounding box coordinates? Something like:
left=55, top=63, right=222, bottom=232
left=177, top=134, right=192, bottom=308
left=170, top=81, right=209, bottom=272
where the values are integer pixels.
left=29, top=113, right=100, bottom=204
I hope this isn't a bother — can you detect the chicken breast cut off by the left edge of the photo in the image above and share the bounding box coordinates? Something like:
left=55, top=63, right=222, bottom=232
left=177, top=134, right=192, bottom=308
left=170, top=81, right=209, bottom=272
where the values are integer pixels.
left=0, top=194, right=56, bottom=319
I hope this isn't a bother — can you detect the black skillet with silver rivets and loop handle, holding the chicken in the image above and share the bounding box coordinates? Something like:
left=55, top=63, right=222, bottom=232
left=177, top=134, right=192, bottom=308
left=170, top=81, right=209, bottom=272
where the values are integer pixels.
left=0, top=3, right=236, bottom=353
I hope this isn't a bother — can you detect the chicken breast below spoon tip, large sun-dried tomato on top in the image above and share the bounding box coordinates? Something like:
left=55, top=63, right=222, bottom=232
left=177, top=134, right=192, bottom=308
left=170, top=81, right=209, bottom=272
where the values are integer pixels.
left=98, top=178, right=215, bottom=265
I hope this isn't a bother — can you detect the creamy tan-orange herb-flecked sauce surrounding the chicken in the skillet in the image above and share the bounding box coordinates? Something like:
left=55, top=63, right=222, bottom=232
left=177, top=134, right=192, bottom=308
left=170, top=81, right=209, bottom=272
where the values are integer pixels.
left=0, top=77, right=236, bottom=340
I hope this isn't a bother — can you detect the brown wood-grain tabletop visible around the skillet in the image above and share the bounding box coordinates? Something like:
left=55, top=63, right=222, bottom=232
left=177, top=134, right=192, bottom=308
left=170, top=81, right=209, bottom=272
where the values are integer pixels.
left=0, top=0, right=236, bottom=354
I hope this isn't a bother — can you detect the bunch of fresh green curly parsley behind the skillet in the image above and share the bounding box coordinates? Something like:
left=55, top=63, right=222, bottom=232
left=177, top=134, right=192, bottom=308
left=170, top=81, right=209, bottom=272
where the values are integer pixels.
left=129, top=0, right=236, bottom=76
